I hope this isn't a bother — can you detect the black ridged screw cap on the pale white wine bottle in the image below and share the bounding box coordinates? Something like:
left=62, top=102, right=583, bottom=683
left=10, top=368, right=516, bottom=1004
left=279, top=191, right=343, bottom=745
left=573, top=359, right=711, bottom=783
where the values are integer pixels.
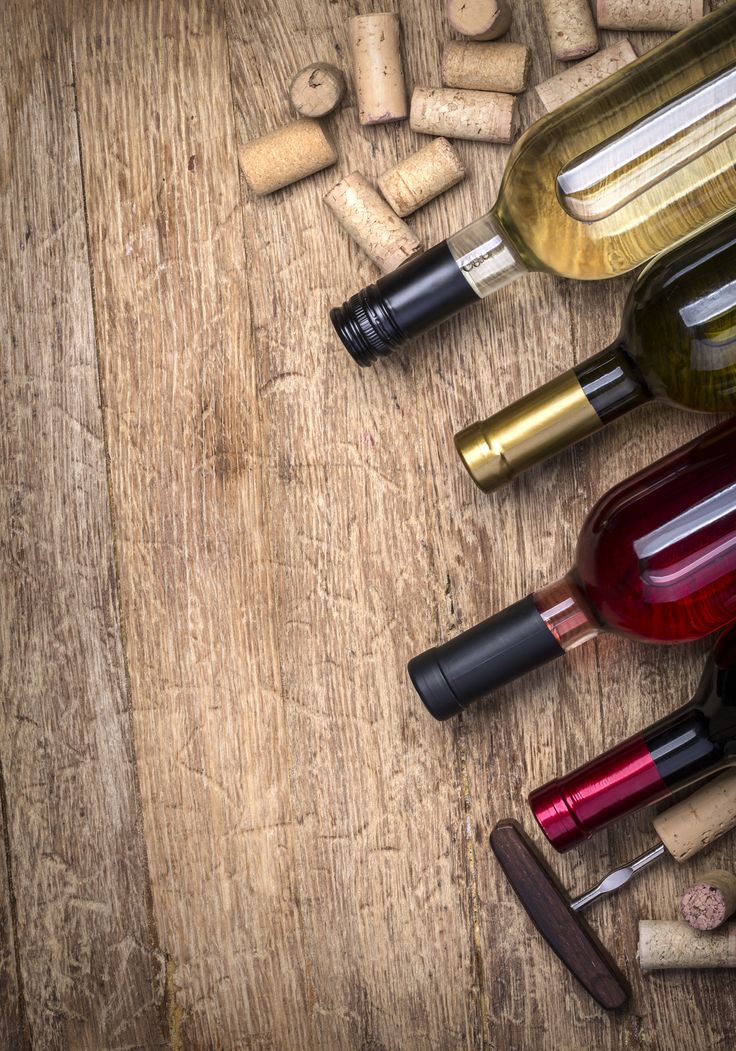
left=330, top=241, right=478, bottom=365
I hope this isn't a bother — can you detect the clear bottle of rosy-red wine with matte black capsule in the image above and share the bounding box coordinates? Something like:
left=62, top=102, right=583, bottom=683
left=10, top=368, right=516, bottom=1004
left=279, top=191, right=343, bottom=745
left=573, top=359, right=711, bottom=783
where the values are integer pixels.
left=409, top=417, right=736, bottom=719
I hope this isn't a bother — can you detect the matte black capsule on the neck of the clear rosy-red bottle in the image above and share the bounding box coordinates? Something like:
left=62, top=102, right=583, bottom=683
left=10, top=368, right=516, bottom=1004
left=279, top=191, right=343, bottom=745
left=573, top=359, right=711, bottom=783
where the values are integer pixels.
left=408, top=595, right=565, bottom=719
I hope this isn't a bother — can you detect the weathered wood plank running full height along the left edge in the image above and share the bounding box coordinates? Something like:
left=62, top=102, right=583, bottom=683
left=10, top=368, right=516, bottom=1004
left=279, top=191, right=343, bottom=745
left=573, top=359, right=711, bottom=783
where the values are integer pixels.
left=0, top=0, right=166, bottom=1051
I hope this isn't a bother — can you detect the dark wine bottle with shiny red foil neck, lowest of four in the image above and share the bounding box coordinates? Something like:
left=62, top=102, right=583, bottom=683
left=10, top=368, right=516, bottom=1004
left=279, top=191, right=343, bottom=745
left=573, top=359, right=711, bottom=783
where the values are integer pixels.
left=529, top=627, right=736, bottom=850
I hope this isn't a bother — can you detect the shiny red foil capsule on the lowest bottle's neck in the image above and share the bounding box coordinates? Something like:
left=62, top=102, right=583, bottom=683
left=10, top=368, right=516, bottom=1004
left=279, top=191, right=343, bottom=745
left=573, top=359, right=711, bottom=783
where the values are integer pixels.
left=529, top=737, right=670, bottom=850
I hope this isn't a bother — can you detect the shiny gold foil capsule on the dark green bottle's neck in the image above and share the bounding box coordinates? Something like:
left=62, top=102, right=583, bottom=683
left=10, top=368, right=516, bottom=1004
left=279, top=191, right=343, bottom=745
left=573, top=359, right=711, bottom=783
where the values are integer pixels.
left=455, top=369, right=602, bottom=493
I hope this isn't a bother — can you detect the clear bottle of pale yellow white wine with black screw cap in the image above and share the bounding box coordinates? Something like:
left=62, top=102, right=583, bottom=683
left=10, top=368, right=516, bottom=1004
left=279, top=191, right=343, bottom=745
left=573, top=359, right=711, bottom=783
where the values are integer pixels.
left=330, top=0, right=736, bottom=365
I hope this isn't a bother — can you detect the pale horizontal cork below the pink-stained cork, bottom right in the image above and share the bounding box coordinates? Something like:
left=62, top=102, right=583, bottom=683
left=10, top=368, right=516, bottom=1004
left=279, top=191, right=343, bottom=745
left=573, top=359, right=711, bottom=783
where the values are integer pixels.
left=639, top=920, right=736, bottom=971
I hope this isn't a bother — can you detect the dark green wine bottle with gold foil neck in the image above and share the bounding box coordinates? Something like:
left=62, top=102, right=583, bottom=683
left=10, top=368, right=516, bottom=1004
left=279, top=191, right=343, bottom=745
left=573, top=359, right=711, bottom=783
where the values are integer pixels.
left=455, top=215, right=736, bottom=492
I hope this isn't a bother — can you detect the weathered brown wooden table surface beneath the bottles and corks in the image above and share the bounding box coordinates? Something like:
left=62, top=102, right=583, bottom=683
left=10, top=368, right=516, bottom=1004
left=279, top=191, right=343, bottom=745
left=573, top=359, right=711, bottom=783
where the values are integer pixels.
left=0, top=0, right=736, bottom=1051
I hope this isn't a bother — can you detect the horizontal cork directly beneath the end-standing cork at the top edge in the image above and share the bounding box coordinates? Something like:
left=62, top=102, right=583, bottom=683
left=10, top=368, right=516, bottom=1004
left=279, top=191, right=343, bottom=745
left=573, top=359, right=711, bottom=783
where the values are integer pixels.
left=442, top=40, right=532, bottom=95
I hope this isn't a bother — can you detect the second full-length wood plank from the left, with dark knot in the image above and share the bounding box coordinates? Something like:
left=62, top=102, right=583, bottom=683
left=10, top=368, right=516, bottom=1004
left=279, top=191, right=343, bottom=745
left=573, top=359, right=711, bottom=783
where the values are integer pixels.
left=75, top=0, right=315, bottom=1051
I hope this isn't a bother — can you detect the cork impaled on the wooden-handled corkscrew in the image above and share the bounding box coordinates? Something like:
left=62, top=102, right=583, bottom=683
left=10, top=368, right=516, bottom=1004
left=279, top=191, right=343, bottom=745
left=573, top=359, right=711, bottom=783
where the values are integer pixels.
left=652, top=770, right=736, bottom=861
